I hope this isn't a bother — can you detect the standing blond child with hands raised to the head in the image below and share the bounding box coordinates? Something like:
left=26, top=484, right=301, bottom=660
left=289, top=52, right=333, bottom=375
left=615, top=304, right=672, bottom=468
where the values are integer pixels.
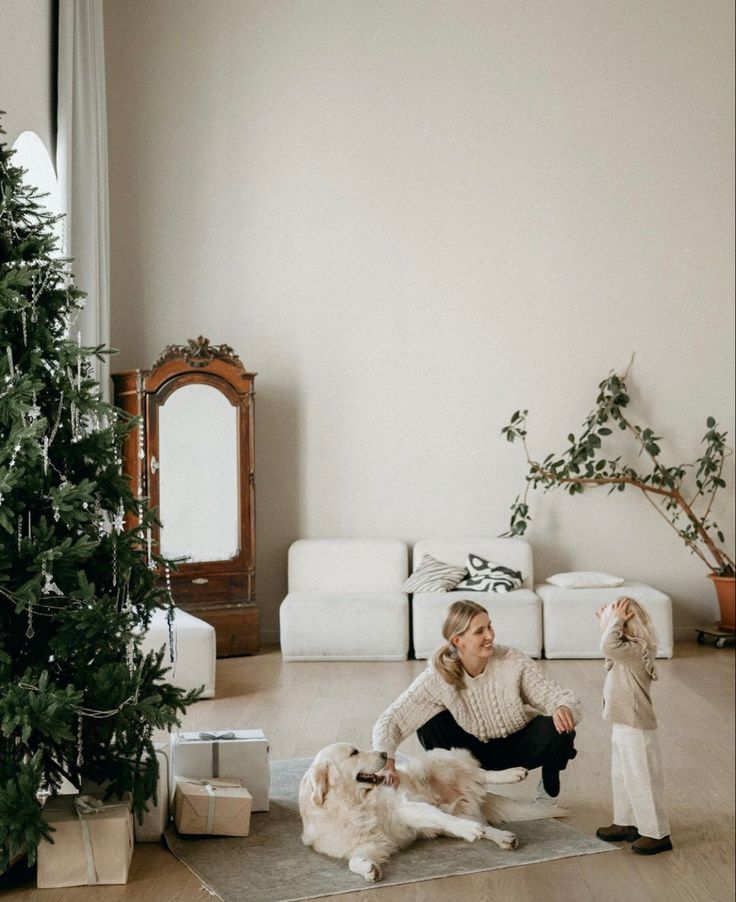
left=596, top=598, right=672, bottom=855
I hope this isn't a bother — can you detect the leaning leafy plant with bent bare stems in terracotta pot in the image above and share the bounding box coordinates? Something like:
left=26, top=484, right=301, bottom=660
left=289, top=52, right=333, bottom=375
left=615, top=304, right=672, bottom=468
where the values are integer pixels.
left=501, top=364, right=736, bottom=630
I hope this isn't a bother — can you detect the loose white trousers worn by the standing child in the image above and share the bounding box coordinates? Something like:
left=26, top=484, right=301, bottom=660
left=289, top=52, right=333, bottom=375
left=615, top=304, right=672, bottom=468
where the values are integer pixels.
left=611, top=723, right=670, bottom=839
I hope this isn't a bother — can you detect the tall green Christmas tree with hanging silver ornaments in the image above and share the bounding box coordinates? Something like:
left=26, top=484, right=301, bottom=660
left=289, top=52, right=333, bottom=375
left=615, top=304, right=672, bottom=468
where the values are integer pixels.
left=0, top=116, right=196, bottom=873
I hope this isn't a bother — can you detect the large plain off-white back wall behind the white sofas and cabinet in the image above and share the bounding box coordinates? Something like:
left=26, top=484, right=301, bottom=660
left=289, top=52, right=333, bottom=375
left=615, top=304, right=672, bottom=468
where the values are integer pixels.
left=105, top=0, right=734, bottom=639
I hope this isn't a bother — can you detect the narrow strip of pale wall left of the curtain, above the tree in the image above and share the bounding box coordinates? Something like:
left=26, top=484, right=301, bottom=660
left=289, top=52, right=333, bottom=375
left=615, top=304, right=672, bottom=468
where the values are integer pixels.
left=0, top=0, right=56, bottom=150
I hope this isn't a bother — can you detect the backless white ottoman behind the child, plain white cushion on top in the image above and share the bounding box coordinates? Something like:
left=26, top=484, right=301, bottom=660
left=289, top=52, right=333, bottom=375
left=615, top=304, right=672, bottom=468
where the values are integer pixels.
left=536, top=583, right=673, bottom=658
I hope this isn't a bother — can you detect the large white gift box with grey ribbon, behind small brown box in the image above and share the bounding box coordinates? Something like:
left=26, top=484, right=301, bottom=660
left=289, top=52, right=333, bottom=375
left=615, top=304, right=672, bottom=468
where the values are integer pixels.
left=170, top=730, right=270, bottom=811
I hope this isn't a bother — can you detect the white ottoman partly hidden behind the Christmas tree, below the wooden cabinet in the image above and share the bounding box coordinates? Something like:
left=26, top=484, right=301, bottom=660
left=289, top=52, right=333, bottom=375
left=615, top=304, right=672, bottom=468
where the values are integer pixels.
left=141, top=608, right=216, bottom=698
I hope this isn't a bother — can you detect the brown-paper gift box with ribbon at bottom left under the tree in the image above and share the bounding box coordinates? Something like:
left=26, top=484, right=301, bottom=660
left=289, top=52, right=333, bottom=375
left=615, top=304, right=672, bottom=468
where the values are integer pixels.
left=37, top=795, right=133, bottom=888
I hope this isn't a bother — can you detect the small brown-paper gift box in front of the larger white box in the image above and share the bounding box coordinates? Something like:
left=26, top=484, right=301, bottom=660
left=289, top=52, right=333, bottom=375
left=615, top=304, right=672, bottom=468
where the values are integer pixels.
left=174, top=777, right=253, bottom=836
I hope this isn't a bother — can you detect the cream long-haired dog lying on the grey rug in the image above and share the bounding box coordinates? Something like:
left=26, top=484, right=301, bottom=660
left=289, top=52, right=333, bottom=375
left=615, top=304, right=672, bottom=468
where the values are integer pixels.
left=299, top=742, right=566, bottom=882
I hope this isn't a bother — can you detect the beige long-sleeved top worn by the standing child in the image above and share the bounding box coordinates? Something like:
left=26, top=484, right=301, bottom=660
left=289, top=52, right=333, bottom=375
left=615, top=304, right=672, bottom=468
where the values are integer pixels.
left=601, top=617, right=657, bottom=730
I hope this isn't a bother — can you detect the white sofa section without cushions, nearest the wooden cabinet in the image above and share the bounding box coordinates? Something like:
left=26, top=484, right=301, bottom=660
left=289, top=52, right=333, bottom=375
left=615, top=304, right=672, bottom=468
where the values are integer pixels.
left=279, top=539, right=409, bottom=661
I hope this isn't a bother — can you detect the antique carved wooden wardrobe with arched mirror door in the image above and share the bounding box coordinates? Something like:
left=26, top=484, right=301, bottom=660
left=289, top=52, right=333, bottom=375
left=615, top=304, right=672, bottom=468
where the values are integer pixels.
left=113, top=337, right=259, bottom=656
